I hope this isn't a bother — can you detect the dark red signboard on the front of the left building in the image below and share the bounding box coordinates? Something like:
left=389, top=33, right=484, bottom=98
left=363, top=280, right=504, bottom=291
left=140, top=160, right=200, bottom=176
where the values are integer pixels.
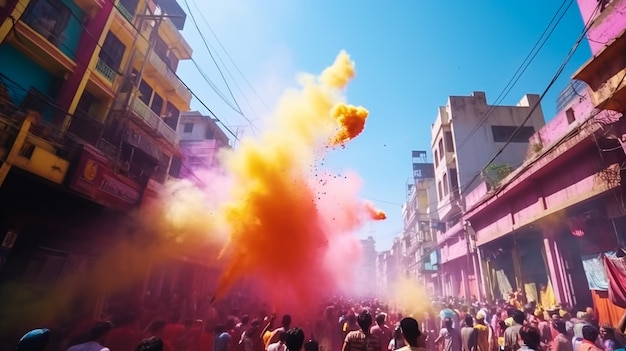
left=69, top=146, right=141, bottom=210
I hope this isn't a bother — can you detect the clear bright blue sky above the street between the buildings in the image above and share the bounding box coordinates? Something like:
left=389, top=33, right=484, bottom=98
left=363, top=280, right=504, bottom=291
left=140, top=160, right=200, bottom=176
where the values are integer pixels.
left=178, top=0, right=590, bottom=250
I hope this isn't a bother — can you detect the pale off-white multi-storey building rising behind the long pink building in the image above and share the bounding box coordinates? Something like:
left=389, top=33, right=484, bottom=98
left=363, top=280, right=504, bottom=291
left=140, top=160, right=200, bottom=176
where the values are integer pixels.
left=431, top=92, right=545, bottom=298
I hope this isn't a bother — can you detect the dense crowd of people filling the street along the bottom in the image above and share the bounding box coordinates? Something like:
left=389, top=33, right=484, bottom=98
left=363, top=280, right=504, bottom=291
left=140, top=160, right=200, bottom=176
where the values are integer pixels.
left=8, top=298, right=626, bottom=351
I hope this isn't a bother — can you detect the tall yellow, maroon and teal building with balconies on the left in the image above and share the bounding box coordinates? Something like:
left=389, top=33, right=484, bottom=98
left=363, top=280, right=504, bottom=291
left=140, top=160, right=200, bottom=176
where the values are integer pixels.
left=0, top=0, right=192, bottom=340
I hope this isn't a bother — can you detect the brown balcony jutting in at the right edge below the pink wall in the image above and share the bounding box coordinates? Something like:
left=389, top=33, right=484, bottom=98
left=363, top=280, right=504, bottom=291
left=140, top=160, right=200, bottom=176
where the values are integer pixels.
left=574, top=30, right=626, bottom=112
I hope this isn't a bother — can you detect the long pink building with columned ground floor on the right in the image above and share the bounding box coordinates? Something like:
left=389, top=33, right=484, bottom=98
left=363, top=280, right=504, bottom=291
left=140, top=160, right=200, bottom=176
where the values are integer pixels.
left=464, top=0, right=626, bottom=324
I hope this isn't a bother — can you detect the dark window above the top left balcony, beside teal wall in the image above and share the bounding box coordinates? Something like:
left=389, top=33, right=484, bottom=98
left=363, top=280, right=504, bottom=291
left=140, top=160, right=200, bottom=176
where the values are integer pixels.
left=22, top=0, right=72, bottom=46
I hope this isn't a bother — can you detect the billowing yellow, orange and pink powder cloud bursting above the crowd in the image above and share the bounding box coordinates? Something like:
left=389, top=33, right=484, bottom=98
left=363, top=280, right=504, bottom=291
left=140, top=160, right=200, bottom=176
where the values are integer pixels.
left=210, top=52, right=383, bottom=308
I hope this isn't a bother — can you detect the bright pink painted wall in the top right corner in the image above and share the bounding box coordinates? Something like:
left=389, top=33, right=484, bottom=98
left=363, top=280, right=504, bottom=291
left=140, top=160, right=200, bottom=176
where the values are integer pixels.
left=578, top=0, right=626, bottom=56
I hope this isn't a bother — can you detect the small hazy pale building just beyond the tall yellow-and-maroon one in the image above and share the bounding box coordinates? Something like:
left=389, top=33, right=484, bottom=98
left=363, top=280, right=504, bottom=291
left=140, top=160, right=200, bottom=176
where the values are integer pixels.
left=177, top=111, right=230, bottom=178
